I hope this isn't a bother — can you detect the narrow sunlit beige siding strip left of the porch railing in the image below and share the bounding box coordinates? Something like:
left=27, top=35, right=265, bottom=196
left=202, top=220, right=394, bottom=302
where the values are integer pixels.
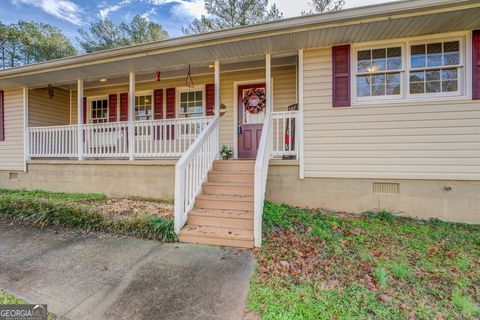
left=0, top=89, right=24, bottom=170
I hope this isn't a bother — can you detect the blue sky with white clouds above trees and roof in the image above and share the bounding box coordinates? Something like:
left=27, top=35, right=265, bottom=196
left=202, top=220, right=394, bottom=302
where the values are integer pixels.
left=0, top=0, right=394, bottom=43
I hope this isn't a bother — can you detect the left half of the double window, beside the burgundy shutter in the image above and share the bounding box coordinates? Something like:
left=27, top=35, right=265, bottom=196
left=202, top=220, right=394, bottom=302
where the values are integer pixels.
left=357, top=47, right=402, bottom=97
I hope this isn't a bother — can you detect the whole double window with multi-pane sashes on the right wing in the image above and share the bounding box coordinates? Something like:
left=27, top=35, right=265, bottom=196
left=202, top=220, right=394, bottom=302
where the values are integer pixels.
left=352, top=36, right=469, bottom=102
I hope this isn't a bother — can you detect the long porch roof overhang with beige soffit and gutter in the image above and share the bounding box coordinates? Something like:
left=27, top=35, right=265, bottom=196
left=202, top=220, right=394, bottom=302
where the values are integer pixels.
left=0, top=0, right=480, bottom=88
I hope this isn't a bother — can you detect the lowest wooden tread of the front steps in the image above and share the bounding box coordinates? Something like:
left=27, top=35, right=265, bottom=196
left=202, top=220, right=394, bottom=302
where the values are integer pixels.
left=180, top=225, right=253, bottom=240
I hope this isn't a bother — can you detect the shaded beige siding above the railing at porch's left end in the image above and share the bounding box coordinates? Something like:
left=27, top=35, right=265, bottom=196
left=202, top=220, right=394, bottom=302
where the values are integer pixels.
left=28, top=87, right=70, bottom=127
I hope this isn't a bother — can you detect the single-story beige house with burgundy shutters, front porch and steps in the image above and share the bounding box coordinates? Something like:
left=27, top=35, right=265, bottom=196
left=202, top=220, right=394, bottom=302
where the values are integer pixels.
left=0, top=0, right=480, bottom=247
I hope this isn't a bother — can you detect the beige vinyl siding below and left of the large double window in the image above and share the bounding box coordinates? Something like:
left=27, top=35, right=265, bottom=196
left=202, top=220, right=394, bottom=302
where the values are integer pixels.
left=304, top=48, right=480, bottom=180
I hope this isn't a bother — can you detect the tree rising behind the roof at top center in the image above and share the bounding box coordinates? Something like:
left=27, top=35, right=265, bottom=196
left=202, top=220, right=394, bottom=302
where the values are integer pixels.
left=182, top=0, right=283, bottom=34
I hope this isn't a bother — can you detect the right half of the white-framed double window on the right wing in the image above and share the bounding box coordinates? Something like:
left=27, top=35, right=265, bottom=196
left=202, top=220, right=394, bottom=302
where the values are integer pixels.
left=409, top=41, right=461, bottom=95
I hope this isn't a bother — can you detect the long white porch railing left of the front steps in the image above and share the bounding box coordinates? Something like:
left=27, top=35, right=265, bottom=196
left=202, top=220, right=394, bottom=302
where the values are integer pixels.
left=28, top=117, right=213, bottom=158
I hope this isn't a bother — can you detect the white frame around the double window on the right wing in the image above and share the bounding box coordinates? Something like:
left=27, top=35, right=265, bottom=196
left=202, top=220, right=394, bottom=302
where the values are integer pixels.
left=350, top=31, right=472, bottom=105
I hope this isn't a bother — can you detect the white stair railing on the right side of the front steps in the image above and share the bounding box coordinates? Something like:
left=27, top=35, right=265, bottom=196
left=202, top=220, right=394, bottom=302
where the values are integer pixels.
left=253, top=112, right=273, bottom=247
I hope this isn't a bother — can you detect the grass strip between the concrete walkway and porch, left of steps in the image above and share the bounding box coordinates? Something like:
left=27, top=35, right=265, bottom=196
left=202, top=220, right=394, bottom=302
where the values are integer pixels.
left=0, top=190, right=176, bottom=241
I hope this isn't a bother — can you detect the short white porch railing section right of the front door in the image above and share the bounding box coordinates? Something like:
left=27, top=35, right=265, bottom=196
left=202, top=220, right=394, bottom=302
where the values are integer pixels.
left=272, top=111, right=300, bottom=159
